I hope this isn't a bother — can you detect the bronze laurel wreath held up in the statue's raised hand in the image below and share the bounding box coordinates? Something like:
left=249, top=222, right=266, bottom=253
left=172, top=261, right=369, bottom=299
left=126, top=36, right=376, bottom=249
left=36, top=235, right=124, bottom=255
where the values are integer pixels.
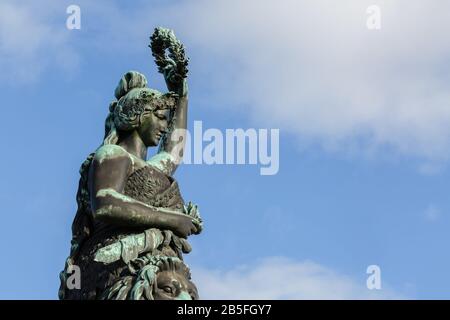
left=149, top=27, right=189, bottom=79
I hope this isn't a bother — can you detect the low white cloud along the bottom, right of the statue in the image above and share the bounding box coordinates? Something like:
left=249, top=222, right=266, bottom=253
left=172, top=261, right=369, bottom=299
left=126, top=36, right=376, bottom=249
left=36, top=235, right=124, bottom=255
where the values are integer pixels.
left=192, top=257, right=403, bottom=300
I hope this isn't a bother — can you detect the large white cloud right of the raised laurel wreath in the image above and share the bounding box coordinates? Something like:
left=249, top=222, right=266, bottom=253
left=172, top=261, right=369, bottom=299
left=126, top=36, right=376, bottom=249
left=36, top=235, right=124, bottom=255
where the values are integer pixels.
left=162, top=0, right=450, bottom=163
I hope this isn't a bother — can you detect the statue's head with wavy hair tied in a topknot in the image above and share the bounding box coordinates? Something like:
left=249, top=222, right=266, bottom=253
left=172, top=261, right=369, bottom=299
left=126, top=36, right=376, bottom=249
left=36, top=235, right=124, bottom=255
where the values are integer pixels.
left=104, top=71, right=177, bottom=147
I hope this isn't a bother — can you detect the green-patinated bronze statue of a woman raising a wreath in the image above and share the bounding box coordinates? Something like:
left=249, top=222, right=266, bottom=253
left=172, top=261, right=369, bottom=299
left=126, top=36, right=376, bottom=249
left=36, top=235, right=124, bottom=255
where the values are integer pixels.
left=59, top=29, right=202, bottom=299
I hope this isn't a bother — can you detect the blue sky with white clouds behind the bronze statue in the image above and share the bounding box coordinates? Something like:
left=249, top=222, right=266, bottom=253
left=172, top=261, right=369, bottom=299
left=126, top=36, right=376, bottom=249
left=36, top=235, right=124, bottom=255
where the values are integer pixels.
left=0, top=0, right=450, bottom=299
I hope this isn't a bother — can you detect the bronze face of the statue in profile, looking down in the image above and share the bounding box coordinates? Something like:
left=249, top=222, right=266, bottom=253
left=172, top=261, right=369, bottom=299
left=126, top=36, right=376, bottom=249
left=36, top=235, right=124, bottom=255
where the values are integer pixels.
left=138, top=109, right=169, bottom=147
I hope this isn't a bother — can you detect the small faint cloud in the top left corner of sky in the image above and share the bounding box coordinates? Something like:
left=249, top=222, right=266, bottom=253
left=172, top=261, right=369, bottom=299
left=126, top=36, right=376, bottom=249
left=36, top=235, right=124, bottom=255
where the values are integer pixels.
left=0, top=1, right=78, bottom=84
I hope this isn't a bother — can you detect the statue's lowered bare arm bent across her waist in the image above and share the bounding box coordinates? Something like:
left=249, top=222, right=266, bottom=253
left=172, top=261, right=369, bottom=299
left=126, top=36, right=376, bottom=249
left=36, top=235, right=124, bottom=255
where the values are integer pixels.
left=89, top=145, right=197, bottom=238
